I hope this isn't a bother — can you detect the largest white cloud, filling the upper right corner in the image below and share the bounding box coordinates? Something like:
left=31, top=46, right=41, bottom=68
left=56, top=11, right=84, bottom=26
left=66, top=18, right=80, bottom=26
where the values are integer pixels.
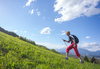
left=54, top=0, right=100, bottom=22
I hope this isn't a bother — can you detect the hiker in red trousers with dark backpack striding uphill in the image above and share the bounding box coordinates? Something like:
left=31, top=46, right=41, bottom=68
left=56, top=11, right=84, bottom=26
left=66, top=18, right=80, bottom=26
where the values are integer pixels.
left=63, top=31, right=84, bottom=63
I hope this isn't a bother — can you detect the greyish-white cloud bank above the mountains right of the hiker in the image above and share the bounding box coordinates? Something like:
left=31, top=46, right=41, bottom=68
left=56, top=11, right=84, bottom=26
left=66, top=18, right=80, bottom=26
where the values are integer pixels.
left=79, top=42, right=100, bottom=51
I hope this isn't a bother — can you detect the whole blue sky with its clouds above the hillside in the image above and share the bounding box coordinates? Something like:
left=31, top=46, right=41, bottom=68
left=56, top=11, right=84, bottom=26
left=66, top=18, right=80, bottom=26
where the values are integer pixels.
left=0, top=0, right=100, bottom=51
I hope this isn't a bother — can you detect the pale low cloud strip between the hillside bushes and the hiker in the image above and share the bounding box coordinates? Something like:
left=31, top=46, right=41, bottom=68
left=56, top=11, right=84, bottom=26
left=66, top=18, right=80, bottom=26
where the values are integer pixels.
left=36, top=42, right=66, bottom=49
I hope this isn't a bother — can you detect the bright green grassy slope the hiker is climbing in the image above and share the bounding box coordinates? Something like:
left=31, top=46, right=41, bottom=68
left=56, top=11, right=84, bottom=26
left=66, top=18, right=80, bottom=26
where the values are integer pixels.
left=0, top=32, right=100, bottom=69
